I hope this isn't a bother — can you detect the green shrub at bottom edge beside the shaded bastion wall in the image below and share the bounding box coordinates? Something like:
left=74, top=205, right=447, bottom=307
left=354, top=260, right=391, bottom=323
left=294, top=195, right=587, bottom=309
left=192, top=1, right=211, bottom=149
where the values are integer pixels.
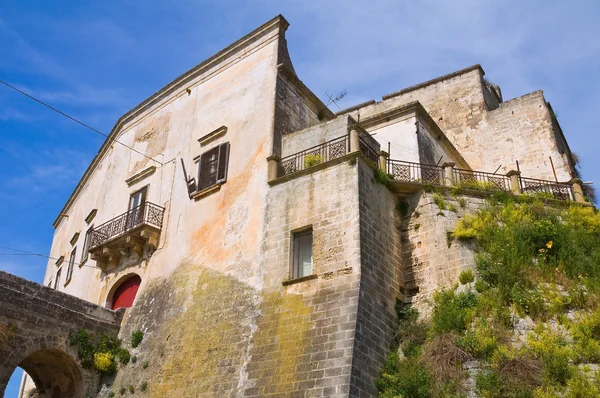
left=377, top=352, right=433, bottom=398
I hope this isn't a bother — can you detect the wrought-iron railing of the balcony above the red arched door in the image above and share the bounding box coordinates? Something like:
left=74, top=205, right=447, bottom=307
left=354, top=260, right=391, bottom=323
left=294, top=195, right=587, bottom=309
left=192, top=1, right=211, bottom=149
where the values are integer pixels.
left=90, top=202, right=165, bottom=249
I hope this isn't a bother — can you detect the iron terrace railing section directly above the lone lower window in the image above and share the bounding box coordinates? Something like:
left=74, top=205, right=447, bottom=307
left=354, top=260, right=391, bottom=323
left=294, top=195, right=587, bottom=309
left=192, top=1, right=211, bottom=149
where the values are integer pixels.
left=279, top=134, right=350, bottom=176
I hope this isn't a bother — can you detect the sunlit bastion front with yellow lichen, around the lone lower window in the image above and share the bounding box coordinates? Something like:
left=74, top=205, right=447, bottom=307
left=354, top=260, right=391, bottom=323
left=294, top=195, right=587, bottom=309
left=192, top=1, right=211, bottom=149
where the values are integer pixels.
left=246, top=157, right=360, bottom=397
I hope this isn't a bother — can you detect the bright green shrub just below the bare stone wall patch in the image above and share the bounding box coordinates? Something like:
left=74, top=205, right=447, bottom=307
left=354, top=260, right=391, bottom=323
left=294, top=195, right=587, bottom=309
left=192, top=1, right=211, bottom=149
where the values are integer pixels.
left=431, top=290, right=477, bottom=334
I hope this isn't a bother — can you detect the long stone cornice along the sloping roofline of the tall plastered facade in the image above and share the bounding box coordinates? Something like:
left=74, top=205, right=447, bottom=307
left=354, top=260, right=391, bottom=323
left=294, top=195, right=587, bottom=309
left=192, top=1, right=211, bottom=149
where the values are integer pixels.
left=52, top=15, right=289, bottom=228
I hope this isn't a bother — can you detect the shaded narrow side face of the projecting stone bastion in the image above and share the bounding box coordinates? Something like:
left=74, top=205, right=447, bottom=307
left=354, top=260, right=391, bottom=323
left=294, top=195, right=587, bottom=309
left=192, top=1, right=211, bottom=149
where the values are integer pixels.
left=350, top=160, right=403, bottom=397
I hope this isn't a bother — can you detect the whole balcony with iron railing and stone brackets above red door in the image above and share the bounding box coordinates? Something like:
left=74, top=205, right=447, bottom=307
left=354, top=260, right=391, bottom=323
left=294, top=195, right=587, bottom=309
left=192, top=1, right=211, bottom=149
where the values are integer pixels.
left=89, top=202, right=165, bottom=271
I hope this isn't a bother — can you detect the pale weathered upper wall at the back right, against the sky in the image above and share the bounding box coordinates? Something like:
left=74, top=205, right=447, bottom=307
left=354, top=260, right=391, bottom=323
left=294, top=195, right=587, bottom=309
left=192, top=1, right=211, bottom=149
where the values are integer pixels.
left=350, top=65, right=572, bottom=181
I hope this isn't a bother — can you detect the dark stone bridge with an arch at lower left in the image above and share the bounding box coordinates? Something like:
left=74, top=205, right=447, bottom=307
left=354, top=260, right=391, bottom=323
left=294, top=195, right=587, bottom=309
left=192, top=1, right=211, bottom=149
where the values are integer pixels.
left=0, top=271, right=123, bottom=398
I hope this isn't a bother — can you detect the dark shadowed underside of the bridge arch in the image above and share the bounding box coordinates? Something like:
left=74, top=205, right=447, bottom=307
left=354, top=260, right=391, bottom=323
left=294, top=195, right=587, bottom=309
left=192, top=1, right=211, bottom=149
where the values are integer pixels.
left=19, top=349, right=84, bottom=398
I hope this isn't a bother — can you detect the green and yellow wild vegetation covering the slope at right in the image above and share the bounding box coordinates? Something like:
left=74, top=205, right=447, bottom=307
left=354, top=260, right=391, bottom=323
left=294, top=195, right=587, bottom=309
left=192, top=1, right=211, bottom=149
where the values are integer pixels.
left=378, top=197, right=600, bottom=398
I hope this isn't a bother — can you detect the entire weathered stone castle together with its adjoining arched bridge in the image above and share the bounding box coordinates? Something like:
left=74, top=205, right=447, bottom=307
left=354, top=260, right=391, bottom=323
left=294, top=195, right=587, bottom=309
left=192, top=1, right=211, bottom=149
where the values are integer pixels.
left=0, top=16, right=584, bottom=397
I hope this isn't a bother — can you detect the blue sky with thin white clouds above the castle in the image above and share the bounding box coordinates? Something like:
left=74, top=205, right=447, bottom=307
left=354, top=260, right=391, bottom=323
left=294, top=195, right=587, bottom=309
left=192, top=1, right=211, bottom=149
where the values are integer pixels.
left=0, top=0, right=600, bottom=398
